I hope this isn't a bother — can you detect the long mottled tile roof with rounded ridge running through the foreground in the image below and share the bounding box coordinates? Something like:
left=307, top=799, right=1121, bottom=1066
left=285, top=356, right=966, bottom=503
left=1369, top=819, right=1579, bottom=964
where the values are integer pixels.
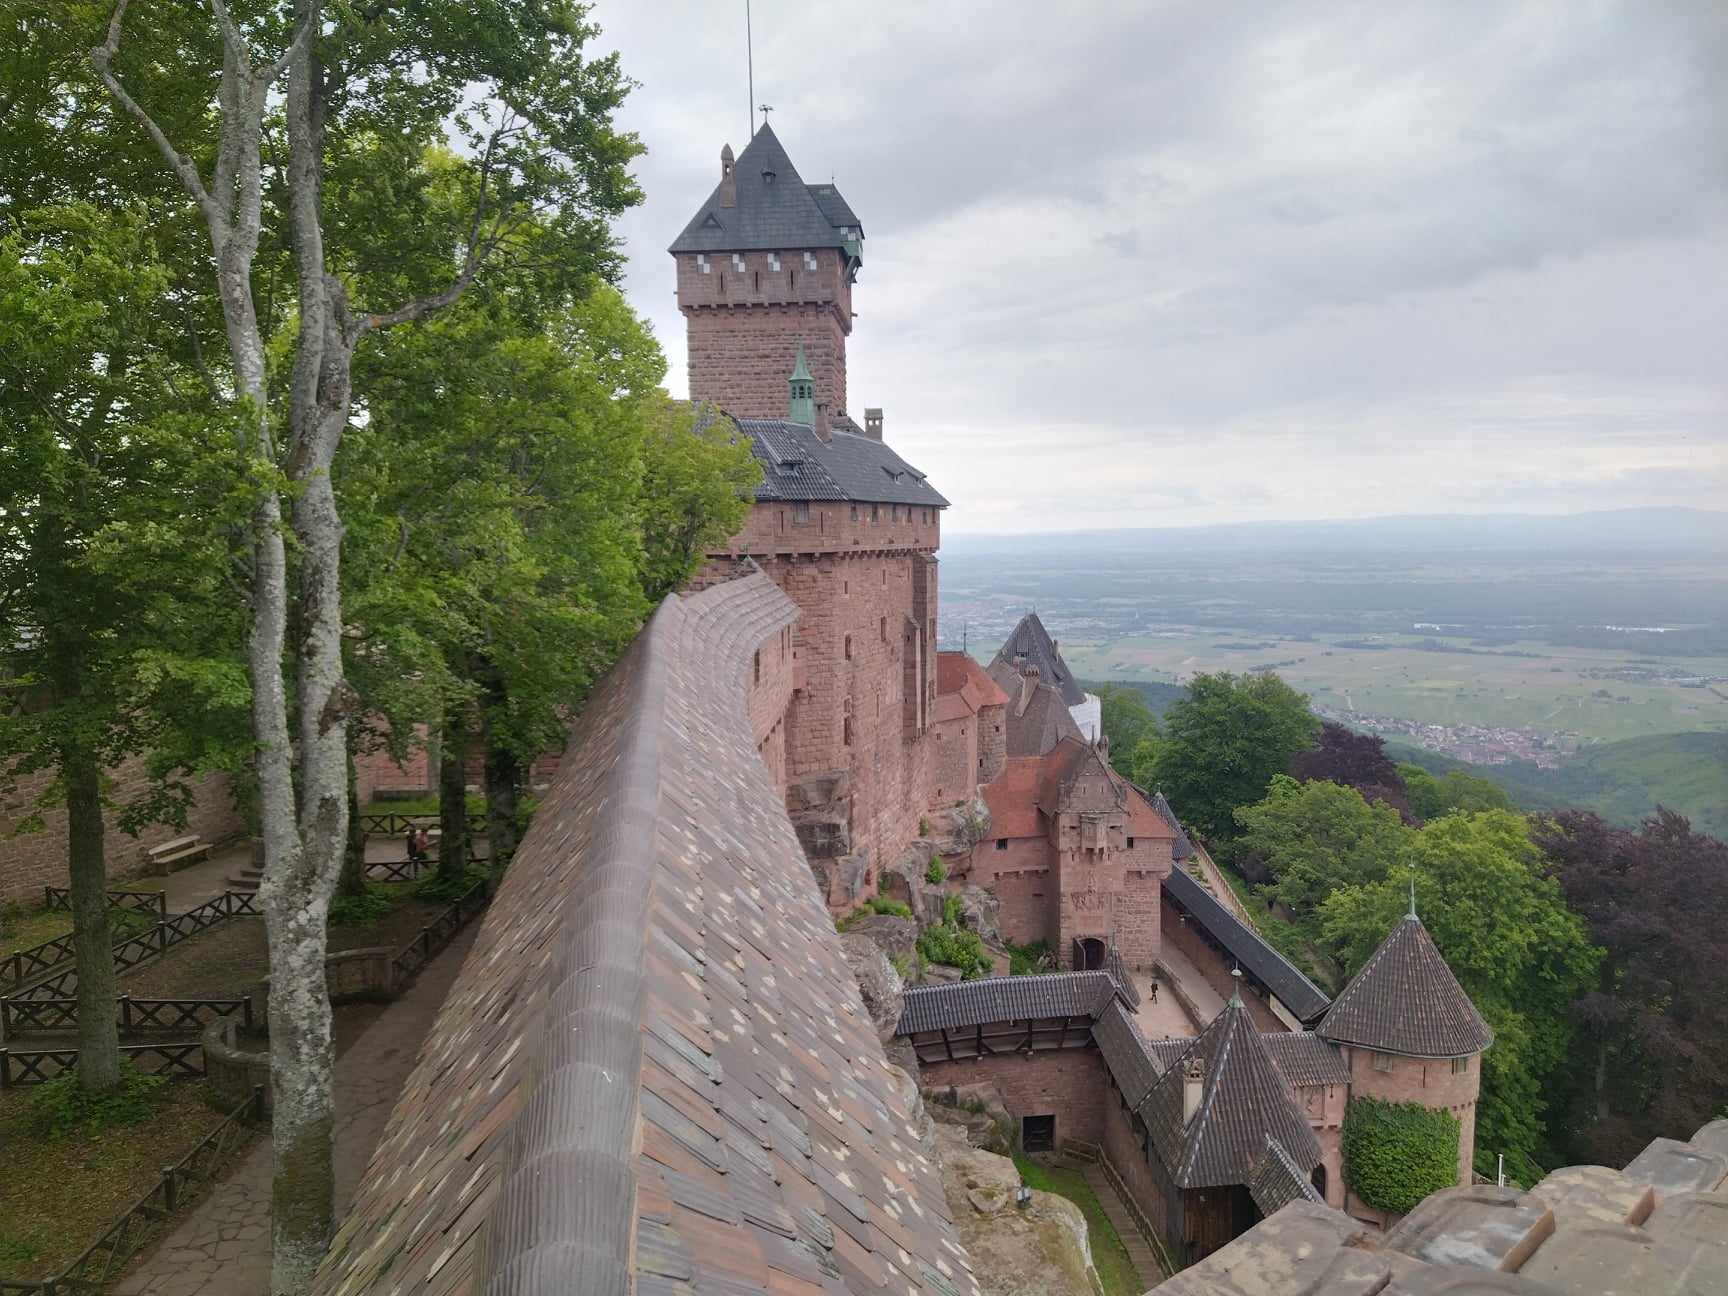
left=314, top=574, right=978, bottom=1296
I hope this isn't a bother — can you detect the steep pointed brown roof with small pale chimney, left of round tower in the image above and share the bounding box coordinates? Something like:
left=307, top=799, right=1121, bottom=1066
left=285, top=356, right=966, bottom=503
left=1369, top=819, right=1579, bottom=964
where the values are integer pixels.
left=1140, top=995, right=1320, bottom=1187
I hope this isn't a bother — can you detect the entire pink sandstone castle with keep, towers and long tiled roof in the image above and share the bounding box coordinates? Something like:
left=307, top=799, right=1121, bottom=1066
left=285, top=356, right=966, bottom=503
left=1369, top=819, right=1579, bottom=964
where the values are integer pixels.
left=316, top=126, right=1491, bottom=1296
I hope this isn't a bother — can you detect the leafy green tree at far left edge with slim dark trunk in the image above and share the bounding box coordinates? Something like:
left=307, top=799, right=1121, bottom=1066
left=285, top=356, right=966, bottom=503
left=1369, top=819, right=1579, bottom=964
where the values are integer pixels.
left=0, top=206, right=244, bottom=1092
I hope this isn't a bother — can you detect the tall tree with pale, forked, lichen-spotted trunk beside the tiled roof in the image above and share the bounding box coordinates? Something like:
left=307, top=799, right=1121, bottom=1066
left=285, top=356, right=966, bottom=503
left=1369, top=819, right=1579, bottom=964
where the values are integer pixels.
left=92, top=0, right=639, bottom=1293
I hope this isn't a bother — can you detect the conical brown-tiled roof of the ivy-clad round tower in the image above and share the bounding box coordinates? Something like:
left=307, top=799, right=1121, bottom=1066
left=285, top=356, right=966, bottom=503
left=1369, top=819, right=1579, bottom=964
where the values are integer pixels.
left=1318, top=914, right=1495, bottom=1058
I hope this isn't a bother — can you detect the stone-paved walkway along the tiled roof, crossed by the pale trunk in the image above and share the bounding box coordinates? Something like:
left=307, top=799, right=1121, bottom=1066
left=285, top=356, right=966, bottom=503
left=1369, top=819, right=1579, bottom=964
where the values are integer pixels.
left=109, top=926, right=480, bottom=1296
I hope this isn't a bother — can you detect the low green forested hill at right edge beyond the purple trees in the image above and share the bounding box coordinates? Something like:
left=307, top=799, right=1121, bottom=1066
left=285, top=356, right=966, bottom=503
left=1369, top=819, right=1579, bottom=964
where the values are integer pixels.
left=1386, top=733, right=1728, bottom=836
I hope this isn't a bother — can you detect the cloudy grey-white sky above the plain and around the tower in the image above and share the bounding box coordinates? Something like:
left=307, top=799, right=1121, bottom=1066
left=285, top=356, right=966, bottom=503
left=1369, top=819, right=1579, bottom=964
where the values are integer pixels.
left=593, top=0, right=1728, bottom=532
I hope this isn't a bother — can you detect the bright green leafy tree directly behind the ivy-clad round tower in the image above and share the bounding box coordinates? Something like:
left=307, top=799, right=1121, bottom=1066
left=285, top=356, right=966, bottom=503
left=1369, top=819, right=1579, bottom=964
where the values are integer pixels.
left=1320, top=810, right=1600, bottom=1159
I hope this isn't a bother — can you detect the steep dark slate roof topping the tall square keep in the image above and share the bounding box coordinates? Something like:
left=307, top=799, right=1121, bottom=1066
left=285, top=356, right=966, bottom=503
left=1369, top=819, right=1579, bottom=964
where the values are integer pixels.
left=667, top=124, right=864, bottom=252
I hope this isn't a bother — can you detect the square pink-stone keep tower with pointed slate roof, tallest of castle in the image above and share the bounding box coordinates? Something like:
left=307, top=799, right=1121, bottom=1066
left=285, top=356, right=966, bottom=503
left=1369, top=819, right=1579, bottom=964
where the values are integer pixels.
left=669, top=124, right=864, bottom=421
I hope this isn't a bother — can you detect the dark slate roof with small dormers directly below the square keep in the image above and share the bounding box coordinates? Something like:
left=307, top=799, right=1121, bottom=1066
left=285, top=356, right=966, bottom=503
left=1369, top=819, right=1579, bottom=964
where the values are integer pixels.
left=734, top=418, right=949, bottom=511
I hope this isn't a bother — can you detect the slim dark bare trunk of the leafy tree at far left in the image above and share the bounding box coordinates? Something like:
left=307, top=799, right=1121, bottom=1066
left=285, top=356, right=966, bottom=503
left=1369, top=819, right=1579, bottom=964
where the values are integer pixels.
left=60, top=748, right=119, bottom=1094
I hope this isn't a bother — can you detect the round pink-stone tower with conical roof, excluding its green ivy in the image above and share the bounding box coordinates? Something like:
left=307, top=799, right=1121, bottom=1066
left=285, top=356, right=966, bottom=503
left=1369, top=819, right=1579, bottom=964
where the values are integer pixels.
left=1318, top=895, right=1495, bottom=1209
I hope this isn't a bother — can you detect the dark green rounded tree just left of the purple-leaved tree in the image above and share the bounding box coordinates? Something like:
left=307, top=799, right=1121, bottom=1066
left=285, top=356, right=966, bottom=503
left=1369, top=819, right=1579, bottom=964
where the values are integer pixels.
left=1153, top=672, right=1320, bottom=843
